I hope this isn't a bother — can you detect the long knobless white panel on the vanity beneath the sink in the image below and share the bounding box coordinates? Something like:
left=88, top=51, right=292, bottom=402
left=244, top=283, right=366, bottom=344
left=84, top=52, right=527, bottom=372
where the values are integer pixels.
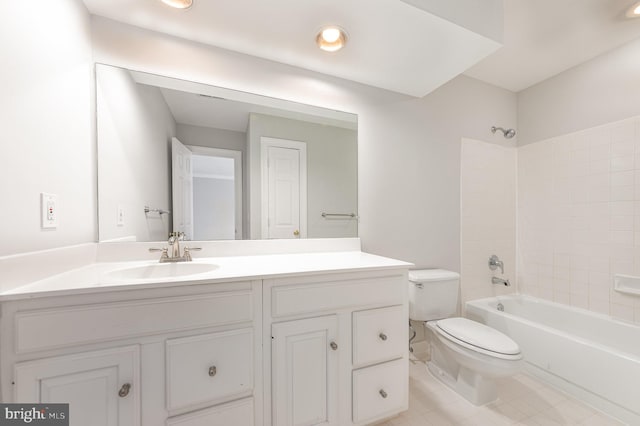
left=15, top=290, right=254, bottom=353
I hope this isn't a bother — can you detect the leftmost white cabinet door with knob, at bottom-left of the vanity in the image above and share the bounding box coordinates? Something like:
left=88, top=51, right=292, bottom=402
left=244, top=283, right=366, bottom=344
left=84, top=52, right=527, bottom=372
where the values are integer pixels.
left=15, top=346, right=140, bottom=426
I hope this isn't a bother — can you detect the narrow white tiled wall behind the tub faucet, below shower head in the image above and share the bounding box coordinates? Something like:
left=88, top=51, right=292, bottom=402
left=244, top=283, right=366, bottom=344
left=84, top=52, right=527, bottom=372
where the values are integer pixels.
left=460, top=139, right=517, bottom=308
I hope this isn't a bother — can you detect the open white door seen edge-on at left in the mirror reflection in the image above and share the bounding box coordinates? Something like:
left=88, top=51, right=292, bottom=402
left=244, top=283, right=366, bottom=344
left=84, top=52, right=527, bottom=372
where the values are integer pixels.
left=171, top=138, right=193, bottom=240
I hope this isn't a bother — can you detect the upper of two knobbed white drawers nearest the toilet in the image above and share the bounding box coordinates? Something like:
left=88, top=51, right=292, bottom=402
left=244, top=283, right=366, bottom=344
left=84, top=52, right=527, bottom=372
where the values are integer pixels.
left=353, top=306, right=408, bottom=368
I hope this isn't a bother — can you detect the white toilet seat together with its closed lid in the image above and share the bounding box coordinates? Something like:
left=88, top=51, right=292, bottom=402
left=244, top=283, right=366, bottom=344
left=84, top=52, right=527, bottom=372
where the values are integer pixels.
left=432, top=318, right=522, bottom=360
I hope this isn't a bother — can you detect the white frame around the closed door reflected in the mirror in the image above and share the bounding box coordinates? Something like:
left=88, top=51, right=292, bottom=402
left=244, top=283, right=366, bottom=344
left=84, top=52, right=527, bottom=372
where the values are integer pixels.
left=260, top=136, right=307, bottom=239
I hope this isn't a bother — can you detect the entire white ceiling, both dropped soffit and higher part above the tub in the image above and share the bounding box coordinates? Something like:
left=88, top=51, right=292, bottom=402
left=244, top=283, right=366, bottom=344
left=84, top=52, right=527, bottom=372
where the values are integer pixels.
left=83, top=0, right=640, bottom=97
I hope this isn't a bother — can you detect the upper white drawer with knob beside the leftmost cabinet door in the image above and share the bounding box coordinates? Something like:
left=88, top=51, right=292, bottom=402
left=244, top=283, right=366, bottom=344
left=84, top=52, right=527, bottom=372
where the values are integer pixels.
left=166, top=328, right=254, bottom=411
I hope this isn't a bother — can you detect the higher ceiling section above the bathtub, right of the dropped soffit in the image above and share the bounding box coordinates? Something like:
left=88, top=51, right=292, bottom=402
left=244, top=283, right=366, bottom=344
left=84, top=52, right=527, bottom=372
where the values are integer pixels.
left=465, top=0, right=640, bottom=92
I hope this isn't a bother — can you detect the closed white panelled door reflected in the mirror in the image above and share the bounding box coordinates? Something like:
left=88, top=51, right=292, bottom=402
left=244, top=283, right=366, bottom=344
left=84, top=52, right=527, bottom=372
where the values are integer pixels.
left=261, top=138, right=307, bottom=238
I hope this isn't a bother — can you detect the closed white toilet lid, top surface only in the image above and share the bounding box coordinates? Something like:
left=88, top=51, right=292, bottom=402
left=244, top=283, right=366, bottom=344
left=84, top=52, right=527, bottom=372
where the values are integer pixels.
left=436, top=318, right=520, bottom=355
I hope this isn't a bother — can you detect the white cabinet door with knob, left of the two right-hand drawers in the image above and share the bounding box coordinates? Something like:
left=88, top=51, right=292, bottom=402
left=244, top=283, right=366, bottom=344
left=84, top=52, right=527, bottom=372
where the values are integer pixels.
left=271, top=315, right=341, bottom=426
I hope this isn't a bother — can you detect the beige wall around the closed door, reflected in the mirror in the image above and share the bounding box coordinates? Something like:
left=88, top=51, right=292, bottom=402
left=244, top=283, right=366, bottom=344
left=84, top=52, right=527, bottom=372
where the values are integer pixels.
left=249, top=114, right=358, bottom=239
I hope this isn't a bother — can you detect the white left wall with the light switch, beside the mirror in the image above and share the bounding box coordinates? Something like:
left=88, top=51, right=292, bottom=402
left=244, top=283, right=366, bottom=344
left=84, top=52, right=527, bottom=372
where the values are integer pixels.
left=0, top=0, right=97, bottom=255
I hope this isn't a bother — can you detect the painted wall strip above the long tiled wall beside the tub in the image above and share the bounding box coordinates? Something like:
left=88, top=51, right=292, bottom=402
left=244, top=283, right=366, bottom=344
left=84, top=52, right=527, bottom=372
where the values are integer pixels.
left=518, top=35, right=640, bottom=145
